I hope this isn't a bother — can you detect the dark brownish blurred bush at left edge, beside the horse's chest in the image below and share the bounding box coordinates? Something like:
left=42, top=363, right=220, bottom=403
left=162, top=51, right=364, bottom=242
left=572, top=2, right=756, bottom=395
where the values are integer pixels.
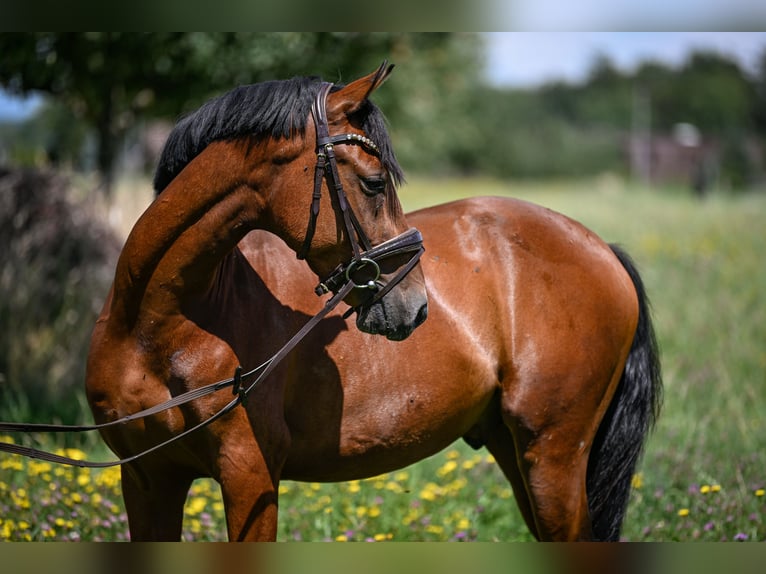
left=0, top=168, right=119, bottom=424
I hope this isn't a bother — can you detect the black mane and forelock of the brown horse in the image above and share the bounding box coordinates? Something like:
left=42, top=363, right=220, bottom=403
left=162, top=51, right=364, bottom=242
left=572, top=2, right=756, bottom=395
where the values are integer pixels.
left=154, top=77, right=404, bottom=194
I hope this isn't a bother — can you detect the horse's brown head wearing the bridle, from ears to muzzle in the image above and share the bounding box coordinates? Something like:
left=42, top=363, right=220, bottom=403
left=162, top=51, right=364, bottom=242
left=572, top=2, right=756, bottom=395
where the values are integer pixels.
left=260, top=63, right=427, bottom=340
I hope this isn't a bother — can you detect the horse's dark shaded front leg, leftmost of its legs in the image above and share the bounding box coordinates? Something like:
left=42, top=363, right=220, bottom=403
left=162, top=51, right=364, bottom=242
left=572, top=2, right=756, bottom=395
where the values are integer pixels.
left=122, top=463, right=193, bottom=542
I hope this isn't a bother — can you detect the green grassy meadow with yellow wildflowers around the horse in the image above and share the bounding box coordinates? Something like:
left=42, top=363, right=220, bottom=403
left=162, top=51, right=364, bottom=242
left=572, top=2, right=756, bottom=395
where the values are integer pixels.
left=0, top=178, right=766, bottom=541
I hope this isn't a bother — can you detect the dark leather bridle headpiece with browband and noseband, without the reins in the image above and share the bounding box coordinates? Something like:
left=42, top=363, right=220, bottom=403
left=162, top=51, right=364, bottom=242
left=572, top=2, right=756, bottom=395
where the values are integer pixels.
left=298, top=82, right=425, bottom=315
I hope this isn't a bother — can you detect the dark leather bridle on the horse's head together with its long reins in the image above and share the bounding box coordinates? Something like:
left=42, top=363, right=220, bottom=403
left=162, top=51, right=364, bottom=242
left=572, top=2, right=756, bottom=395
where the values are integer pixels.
left=0, top=82, right=425, bottom=468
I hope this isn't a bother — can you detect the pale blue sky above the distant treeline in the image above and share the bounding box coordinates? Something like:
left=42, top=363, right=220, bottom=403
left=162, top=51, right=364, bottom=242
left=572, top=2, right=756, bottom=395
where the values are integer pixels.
left=0, top=33, right=766, bottom=120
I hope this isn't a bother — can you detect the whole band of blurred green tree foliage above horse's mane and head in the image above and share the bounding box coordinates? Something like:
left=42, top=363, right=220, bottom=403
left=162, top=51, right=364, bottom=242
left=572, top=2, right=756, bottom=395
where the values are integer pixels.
left=0, top=32, right=479, bottom=194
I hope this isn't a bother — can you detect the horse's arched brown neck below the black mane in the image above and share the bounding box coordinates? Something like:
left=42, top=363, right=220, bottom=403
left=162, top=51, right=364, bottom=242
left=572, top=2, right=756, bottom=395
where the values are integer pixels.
left=111, top=143, right=259, bottom=329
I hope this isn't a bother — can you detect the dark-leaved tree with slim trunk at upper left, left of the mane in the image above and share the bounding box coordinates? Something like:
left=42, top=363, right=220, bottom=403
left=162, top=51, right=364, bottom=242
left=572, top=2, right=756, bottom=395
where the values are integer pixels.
left=0, top=32, right=204, bottom=196
